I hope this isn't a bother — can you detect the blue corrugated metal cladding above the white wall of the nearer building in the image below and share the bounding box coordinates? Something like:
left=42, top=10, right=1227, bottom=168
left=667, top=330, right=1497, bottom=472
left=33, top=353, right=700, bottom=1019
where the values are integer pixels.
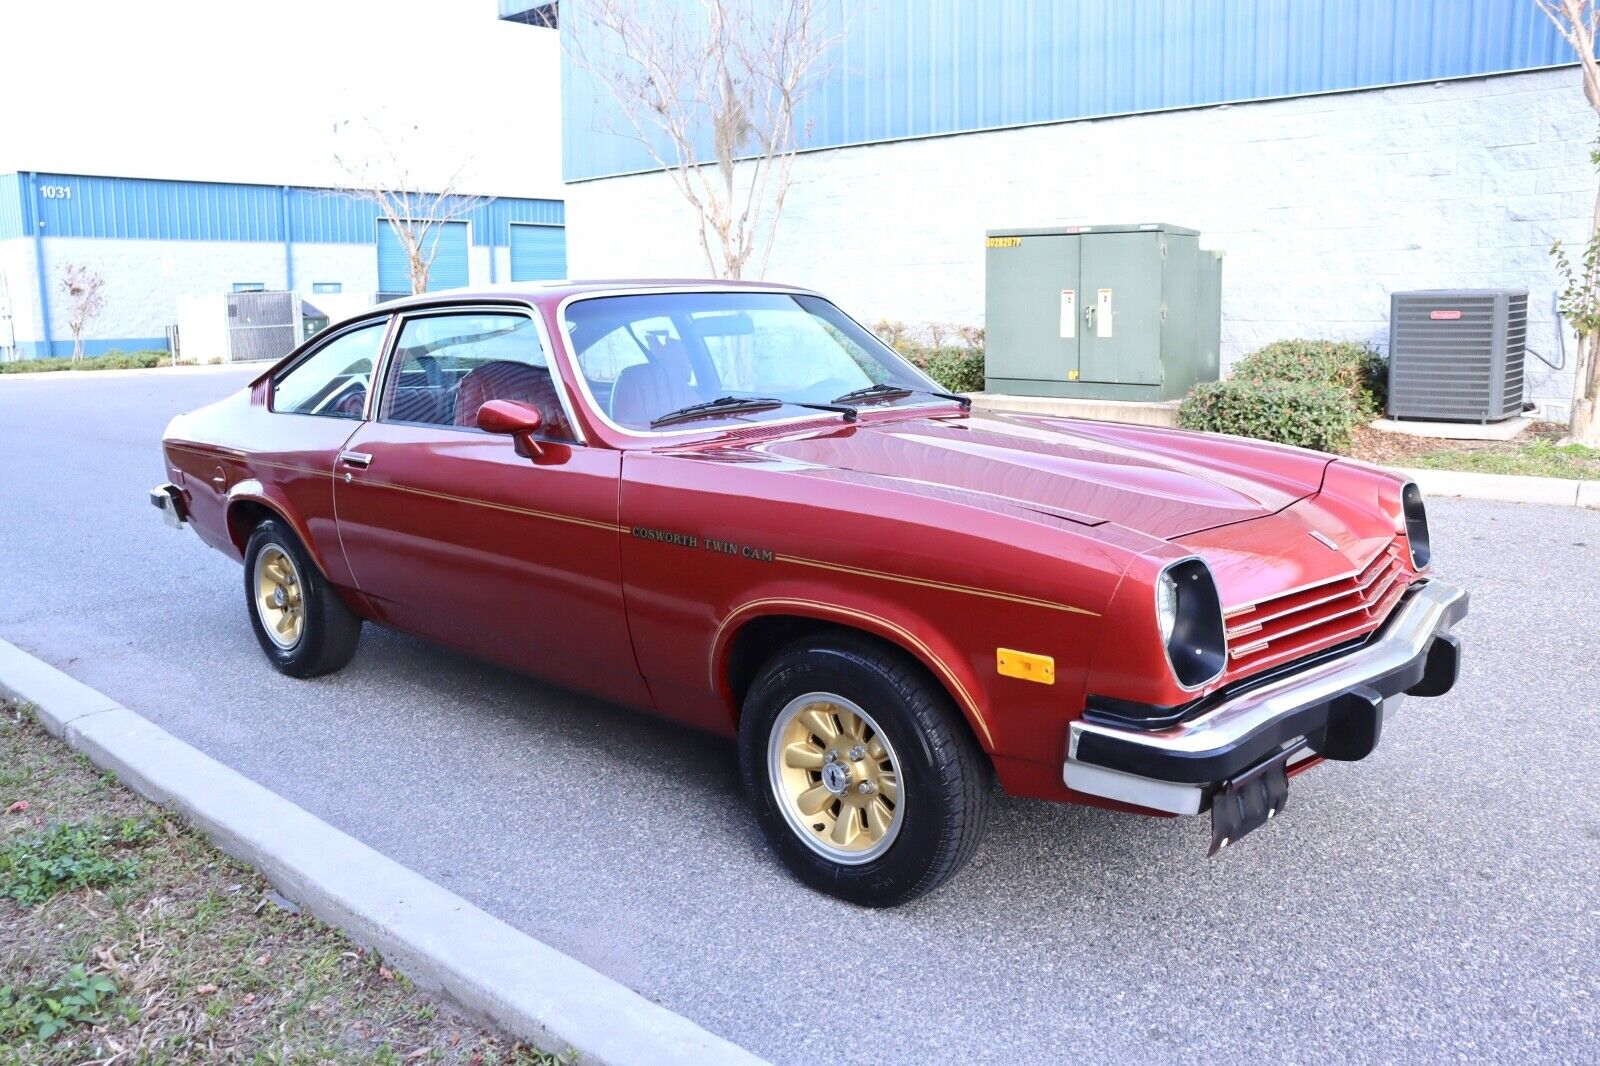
left=562, top=0, right=1571, bottom=181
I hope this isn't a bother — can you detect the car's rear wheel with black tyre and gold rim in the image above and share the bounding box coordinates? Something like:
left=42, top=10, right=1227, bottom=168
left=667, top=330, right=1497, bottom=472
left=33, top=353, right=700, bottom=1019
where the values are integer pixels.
left=245, top=519, right=362, bottom=677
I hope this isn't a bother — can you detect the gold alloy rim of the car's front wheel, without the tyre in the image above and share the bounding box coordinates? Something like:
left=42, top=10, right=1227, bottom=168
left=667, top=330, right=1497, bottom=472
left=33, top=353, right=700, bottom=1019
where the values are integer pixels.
left=766, top=691, right=906, bottom=866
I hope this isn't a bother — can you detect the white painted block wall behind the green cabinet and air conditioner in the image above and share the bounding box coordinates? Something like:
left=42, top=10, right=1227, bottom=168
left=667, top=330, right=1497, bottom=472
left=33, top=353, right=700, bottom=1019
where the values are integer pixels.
left=566, top=67, right=1597, bottom=419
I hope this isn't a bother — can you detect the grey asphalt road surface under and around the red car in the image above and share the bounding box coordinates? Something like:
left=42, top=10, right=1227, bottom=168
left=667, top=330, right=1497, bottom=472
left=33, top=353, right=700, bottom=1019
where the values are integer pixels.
left=0, top=370, right=1600, bottom=1063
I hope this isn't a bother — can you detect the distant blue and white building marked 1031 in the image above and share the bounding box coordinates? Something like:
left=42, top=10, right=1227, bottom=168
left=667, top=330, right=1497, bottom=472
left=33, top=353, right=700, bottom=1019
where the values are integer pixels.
left=0, top=171, right=566, bottom=357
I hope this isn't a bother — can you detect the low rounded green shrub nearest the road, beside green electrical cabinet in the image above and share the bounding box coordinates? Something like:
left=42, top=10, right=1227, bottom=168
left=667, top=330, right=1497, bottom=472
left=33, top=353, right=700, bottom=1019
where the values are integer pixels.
left=1178, top=378, right=1357, bottom=451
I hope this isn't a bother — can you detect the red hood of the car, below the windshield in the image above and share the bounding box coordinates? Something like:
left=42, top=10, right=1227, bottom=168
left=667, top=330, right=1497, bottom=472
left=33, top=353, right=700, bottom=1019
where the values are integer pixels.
left=755, top=406, right=1331, bottom=539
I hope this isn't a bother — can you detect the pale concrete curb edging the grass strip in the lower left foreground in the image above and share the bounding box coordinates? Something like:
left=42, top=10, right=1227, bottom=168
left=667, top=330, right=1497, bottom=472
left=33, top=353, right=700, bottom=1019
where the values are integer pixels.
left=0, top=640, right=763, bottom=1064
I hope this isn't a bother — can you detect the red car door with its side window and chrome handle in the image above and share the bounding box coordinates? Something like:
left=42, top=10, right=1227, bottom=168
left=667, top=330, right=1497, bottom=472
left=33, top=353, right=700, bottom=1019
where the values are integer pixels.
left=334, top=307, right=648, bottom=706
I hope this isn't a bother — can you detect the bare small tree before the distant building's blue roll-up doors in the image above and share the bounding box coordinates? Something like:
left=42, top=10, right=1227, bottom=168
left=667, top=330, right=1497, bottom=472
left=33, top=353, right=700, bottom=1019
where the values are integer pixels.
left=334, top=120, right=493, bottom=293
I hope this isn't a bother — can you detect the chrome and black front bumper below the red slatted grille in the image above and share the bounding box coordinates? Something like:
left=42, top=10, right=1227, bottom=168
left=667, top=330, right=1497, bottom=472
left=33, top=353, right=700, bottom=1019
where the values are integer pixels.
left=1062, top=581, right=1467, bottom=815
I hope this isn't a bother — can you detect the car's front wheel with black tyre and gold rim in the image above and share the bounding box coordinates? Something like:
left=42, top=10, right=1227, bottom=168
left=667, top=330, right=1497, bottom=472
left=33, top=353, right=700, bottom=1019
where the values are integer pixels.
left=739, top=635, right=992, bottom=908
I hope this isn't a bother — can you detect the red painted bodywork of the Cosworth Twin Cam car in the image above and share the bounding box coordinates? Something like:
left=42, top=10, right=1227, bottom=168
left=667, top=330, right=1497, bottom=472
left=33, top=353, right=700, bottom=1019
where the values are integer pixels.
left=156, top=283, right=1418, bottom=807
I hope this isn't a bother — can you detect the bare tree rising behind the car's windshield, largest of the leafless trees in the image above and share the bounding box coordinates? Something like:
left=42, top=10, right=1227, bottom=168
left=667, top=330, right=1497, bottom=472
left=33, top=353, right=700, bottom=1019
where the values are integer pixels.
left=562, top=0, right=838, bottom=277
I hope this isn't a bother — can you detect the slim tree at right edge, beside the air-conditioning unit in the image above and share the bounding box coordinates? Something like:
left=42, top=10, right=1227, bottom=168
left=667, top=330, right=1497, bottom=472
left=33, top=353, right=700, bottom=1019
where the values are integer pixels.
left=1533, top=0, right=1600, bottom=448
